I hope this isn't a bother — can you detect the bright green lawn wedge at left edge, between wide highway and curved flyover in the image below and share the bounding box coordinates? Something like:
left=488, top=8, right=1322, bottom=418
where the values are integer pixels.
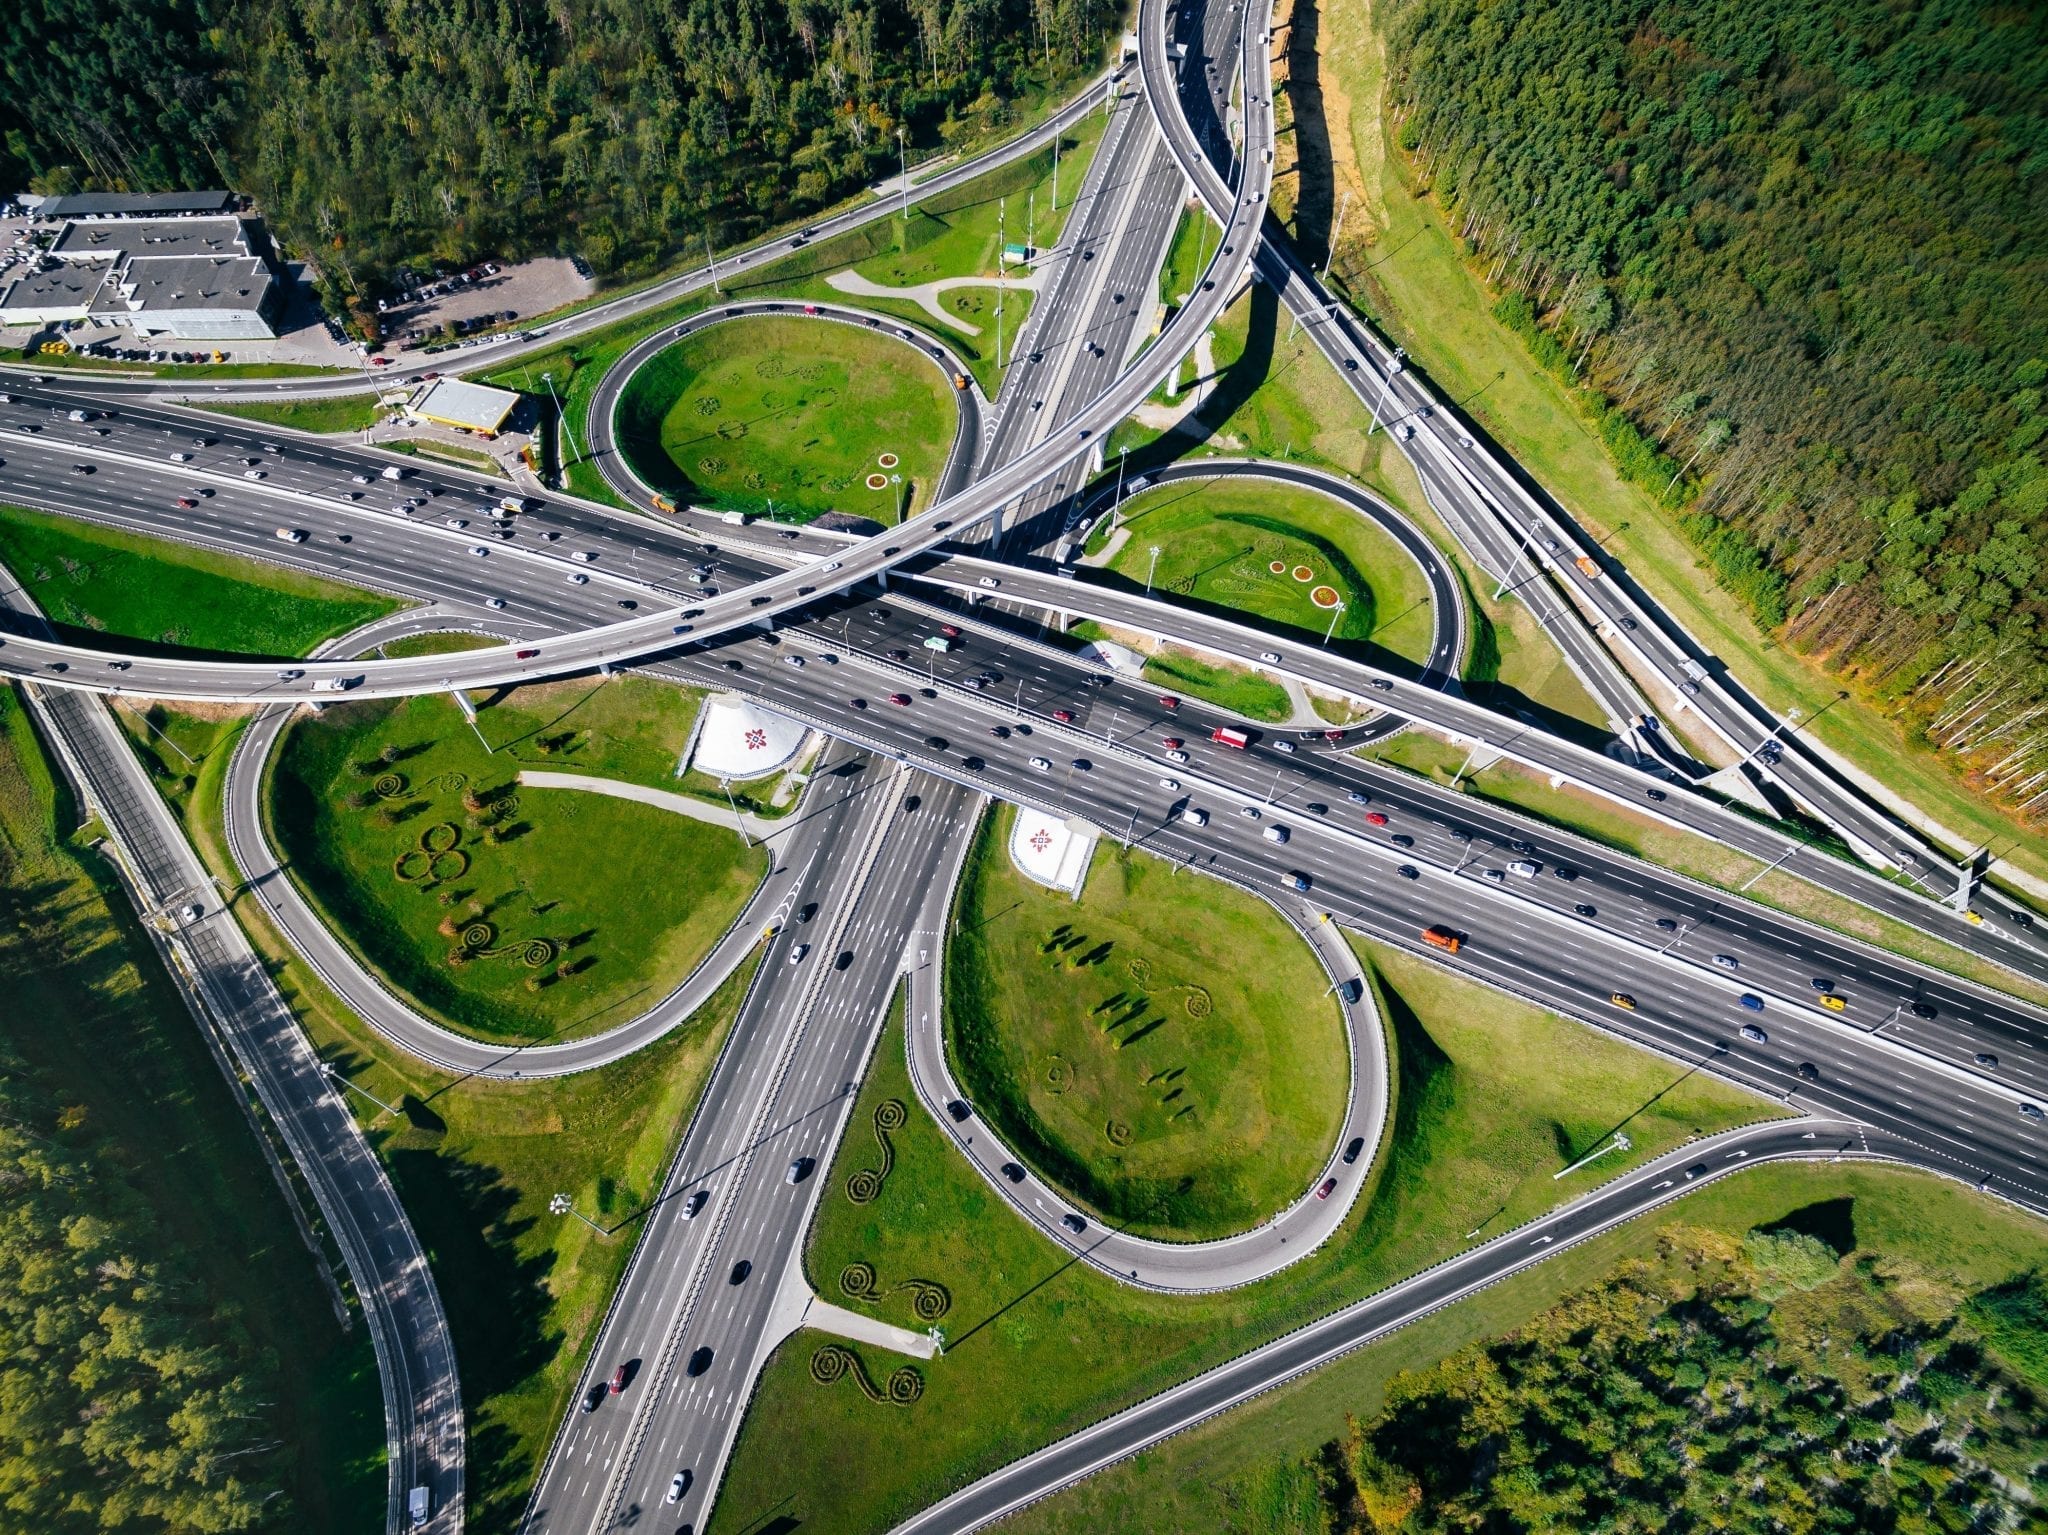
left=0, top=506, right=403, bottom=655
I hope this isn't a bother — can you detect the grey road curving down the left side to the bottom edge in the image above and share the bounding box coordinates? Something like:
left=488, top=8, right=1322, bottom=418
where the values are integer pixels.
left=0, top=571, right=467, bottom=1535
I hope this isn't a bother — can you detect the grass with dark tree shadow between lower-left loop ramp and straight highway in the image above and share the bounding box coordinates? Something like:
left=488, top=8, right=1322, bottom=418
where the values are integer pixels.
left=149, top=699, right=758, bottom=1533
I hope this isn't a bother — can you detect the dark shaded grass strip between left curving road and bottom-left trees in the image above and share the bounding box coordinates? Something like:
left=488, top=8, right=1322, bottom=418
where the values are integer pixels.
left=0, top=688, right=385, bottom=1529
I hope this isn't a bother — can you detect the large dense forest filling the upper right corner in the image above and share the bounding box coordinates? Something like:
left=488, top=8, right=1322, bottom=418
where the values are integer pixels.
left=1389, top=0, right=2048, bottom=830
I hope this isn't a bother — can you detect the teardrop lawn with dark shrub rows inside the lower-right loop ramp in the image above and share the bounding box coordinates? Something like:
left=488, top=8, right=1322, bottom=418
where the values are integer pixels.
left=946, top=806, right=1348, bottom=1240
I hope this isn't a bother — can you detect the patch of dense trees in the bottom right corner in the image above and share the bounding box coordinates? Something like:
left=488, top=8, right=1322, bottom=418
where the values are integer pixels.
left=1305, top=1230, right=2048, bottom=1535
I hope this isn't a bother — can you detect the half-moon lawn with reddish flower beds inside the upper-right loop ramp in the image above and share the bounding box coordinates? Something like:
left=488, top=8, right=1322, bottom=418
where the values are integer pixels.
left=1108, top=479, right=1436, bottom=665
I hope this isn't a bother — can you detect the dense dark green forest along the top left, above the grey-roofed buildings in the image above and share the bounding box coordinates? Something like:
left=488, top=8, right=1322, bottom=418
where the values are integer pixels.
left=0, top=0, right=1122, bottom=282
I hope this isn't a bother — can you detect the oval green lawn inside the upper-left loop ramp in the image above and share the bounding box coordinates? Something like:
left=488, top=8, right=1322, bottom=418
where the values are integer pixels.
left=618, top=315, right=958, bottom=522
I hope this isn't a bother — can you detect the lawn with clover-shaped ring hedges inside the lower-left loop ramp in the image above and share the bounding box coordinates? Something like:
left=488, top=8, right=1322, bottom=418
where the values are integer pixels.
left=264, top=679, right=764, bottom=1040
